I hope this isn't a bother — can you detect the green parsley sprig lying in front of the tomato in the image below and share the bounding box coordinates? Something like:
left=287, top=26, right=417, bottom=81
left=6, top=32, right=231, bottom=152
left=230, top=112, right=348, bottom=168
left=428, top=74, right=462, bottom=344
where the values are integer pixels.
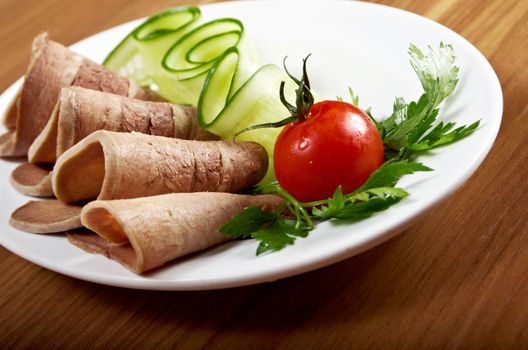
left=220, top=160, right=432, bottom=255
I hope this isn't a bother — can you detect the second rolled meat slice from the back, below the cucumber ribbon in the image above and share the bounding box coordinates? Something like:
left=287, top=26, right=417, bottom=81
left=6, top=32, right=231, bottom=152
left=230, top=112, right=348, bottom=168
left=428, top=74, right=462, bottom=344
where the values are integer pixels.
left=28, top=87, right=218, bottom=163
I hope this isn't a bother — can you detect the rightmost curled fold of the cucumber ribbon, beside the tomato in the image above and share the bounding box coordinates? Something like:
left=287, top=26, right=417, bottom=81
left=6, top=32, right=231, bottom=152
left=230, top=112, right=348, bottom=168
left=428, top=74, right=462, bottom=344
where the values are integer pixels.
left=198, top=48, right=295, bottom=183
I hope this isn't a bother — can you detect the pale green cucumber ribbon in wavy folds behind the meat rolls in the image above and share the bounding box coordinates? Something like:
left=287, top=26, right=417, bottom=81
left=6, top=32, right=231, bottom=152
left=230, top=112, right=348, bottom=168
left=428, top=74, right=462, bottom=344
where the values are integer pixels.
left=104, top=6, right=295, bottom=183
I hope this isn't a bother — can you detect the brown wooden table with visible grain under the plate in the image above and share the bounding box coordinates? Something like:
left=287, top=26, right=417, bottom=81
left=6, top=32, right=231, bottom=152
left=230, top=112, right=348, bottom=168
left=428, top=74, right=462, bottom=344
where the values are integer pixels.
left=0, top=0, right=528, bottom=349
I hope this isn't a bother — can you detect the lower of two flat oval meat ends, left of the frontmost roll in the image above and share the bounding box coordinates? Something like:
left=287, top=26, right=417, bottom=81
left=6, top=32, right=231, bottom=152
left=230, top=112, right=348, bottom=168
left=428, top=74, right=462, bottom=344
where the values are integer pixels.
left=9, top=199, right=82, bottom=233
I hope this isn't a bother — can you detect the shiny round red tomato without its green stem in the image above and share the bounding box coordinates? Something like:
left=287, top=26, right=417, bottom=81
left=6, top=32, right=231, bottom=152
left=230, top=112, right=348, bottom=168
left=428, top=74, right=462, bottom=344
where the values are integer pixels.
left=273, top=101, right=383, bottom=202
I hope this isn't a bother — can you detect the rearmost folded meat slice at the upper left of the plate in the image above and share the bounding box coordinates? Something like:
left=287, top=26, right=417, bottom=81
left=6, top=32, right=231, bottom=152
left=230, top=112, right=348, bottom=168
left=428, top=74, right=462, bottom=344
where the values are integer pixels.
left=0, top=33, right=160, bottom=157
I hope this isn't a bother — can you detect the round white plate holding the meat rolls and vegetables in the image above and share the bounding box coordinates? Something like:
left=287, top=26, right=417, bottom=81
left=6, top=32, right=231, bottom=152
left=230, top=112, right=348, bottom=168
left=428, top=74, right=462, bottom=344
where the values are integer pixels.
left=0, top=1, right=502, bottom=290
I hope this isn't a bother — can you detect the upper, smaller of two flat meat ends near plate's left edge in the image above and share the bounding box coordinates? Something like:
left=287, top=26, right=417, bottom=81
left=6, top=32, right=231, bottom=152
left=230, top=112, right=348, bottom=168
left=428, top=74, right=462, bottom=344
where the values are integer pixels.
left=10, top=163, right=54, bottom=197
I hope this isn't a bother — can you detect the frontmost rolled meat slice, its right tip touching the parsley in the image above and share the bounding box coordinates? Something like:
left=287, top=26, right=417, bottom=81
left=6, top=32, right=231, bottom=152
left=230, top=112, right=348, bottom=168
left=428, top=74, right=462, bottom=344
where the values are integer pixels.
left=68, top=192, right=282, bottom=273
